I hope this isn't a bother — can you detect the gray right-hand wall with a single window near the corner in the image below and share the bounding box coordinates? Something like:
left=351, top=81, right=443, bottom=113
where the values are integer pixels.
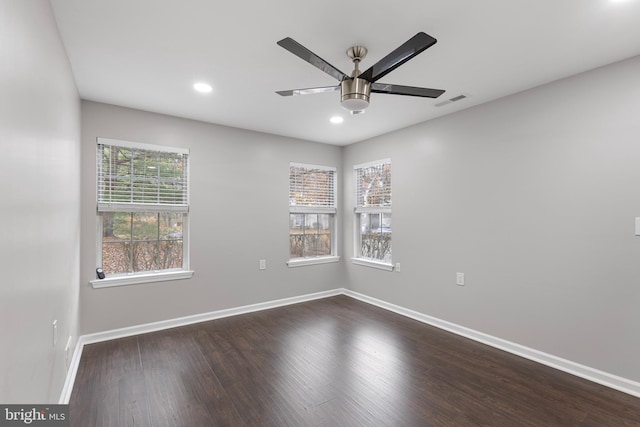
left=343, top=57, right=640, bottom=381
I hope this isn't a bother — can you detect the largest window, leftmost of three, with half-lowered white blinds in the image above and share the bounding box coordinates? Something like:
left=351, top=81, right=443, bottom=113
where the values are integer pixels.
left=91, top=138, right=192, bottom=287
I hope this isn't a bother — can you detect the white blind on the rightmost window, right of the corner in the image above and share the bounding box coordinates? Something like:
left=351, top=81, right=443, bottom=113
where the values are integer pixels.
left=354, top=159, right=391, bottom=211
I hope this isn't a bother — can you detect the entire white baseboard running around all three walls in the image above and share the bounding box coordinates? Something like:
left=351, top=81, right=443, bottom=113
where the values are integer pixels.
left=58, top=288, right=640, bottom=404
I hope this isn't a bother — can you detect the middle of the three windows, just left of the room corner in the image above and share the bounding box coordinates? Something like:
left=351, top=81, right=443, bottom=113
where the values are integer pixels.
left=288, top=163, right=339, bottom=267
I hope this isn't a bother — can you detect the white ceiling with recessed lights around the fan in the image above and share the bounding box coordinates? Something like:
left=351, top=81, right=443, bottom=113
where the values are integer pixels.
left=51, top=0, right=640, bottom=145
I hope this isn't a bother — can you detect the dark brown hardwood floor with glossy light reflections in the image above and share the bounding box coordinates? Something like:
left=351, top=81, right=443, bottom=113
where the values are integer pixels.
left=70, top=296, right=640, bottom=427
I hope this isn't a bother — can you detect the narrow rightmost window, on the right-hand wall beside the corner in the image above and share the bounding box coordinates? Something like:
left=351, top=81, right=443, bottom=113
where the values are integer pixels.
left=353, top=159, right=392, bottom=270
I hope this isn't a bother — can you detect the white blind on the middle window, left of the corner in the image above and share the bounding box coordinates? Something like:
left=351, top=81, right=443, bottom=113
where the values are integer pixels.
left=289, top=163, right=336, bottom=213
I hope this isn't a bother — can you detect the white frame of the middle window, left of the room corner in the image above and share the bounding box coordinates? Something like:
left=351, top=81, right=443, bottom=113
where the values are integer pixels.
left=287, top=162, right=340, bottom=267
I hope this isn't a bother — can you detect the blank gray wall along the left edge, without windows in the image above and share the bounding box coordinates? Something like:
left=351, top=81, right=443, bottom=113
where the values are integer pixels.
left=0, top=0, right=80, bottom=403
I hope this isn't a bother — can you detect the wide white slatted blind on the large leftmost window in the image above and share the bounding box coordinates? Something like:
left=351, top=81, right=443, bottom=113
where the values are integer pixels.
left=97, top=138, right=189, bottom=213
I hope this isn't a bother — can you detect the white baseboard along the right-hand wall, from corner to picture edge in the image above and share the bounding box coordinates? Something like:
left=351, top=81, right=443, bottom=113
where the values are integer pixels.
left=343, top=289, right=640, bottom=397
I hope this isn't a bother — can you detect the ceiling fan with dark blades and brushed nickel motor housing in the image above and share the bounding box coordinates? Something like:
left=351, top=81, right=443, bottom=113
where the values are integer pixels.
left=276, top=32, right=445, bottom=114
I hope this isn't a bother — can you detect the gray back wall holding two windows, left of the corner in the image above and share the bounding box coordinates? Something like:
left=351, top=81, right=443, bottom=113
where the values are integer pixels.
left=81, top=101, right=343, bottom=334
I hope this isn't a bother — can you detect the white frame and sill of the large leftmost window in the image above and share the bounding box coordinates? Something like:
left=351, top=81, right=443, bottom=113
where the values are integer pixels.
left=89, top=138, right=194, bottom=288
